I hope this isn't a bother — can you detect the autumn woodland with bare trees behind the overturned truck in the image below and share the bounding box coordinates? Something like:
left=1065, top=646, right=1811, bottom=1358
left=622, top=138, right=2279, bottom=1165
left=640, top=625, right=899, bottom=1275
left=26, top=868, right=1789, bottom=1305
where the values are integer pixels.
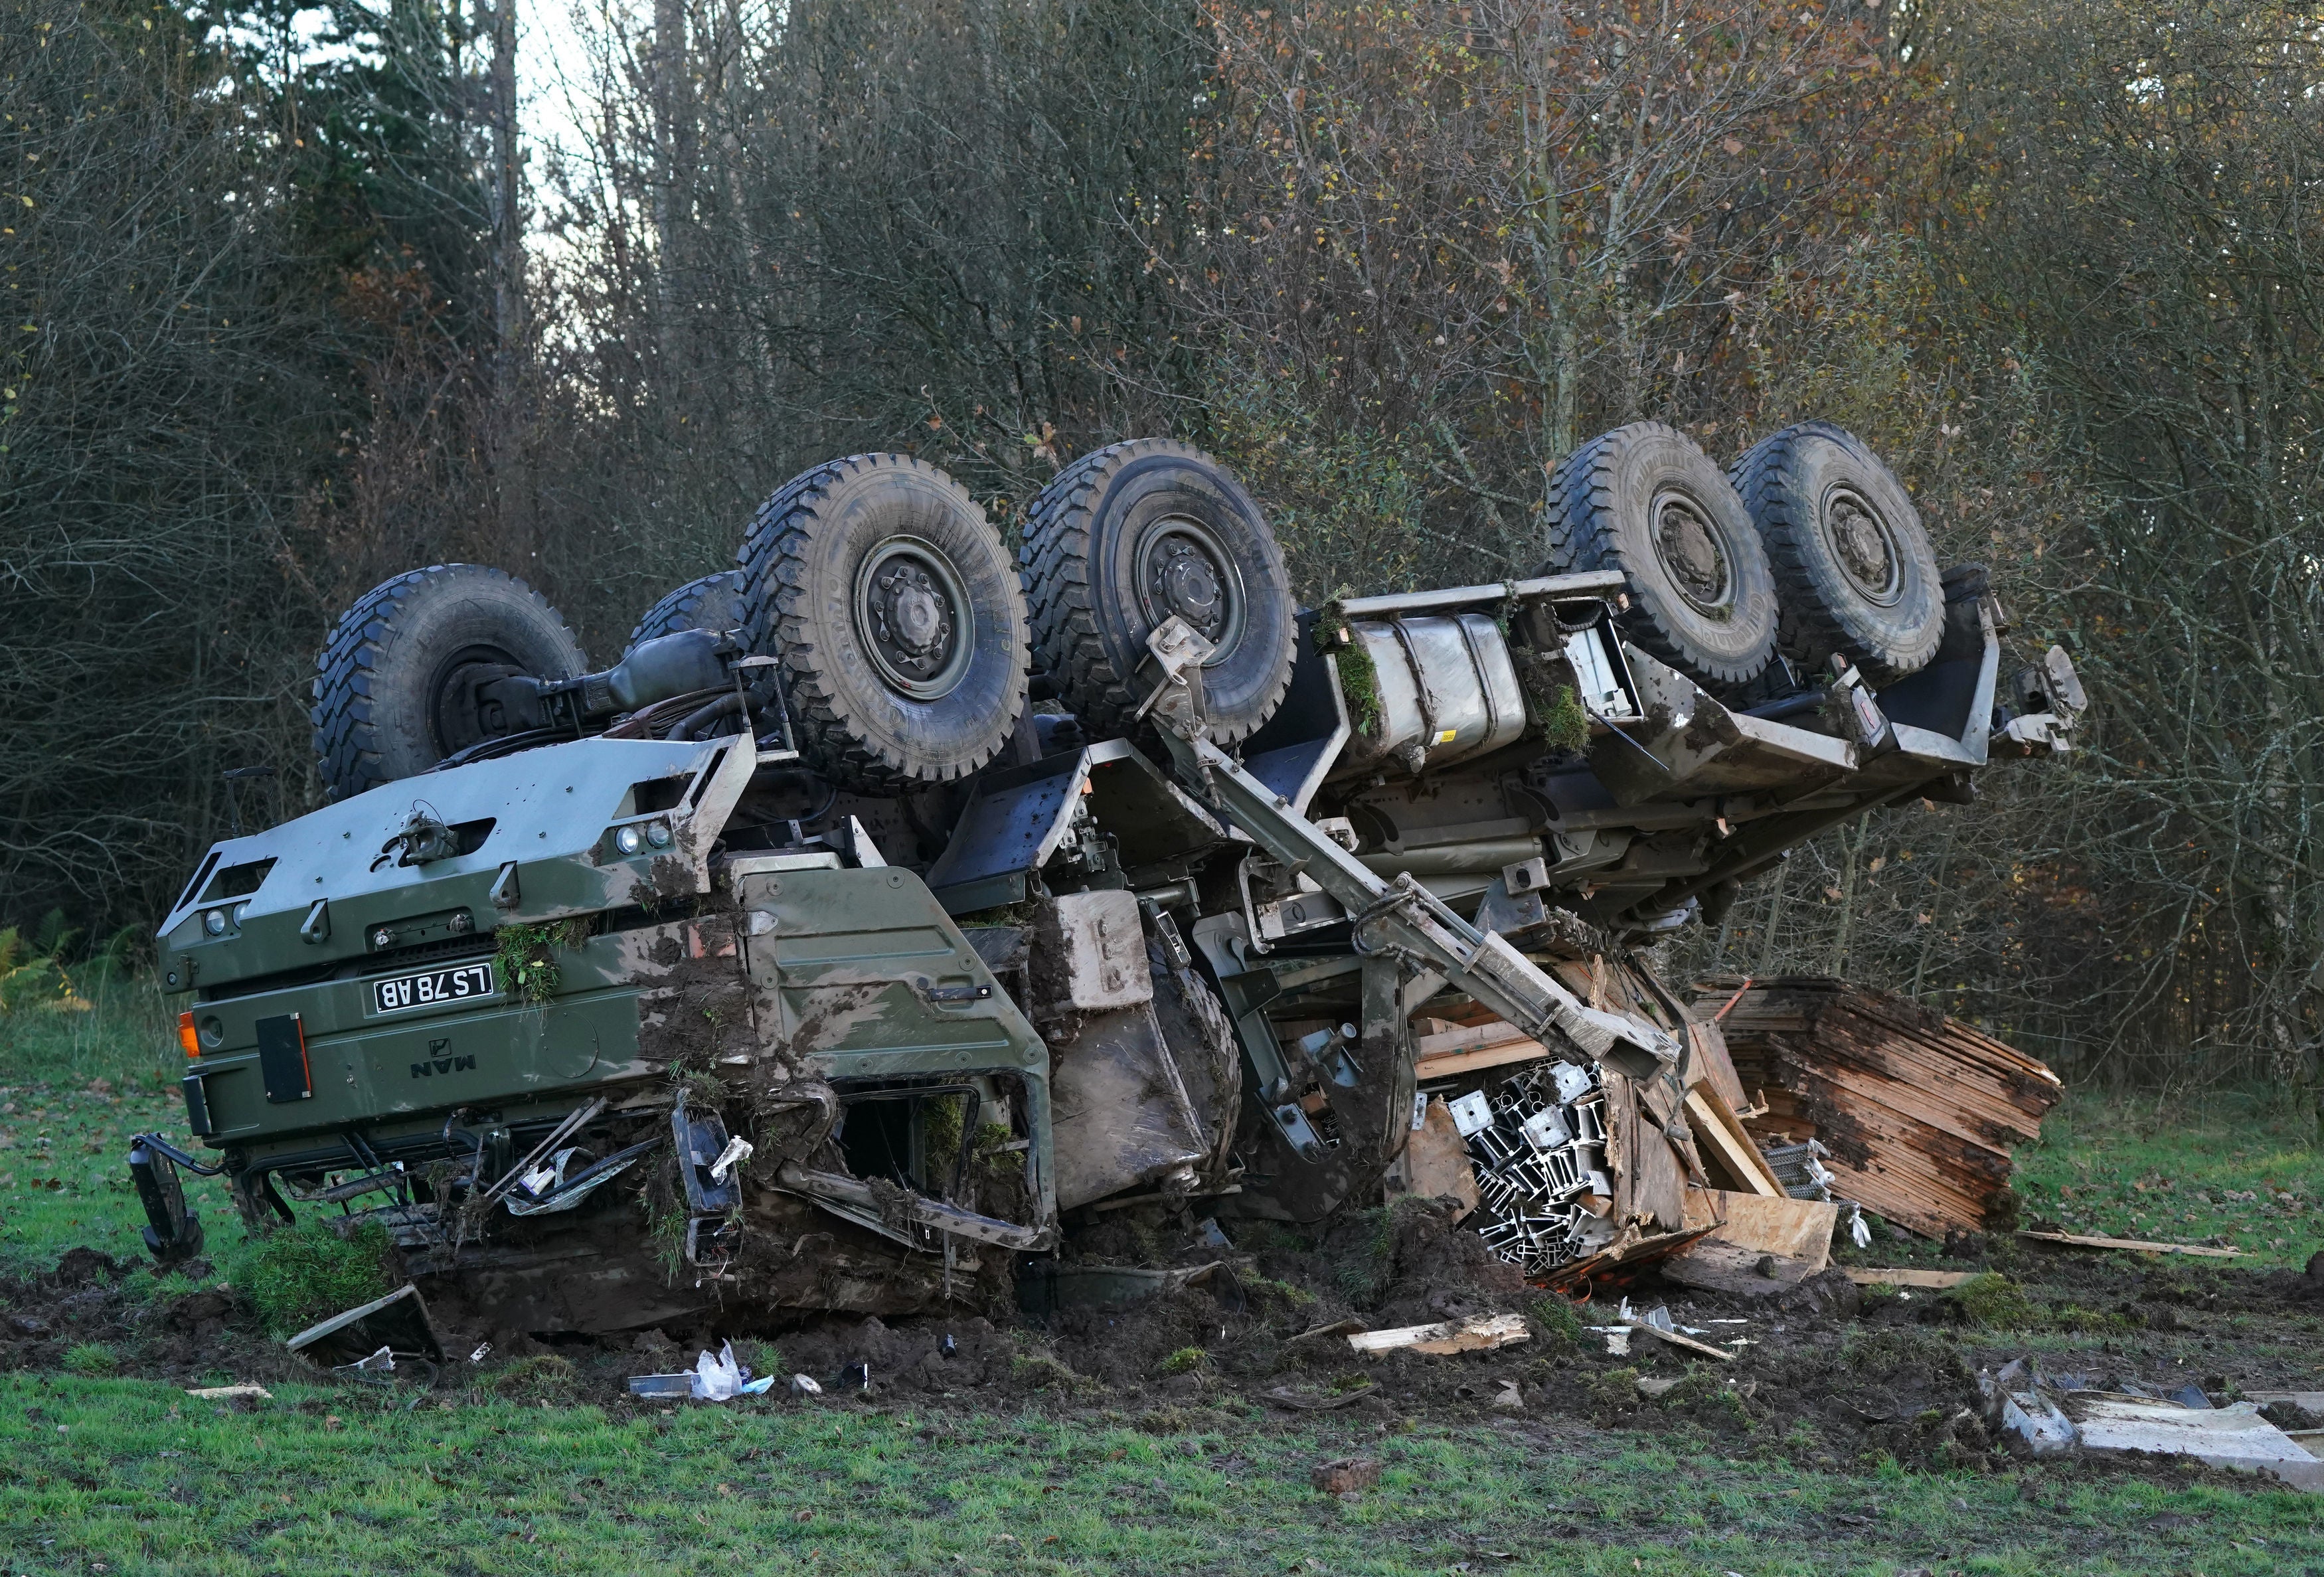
left=0, top=0, right=2324, bottom=1089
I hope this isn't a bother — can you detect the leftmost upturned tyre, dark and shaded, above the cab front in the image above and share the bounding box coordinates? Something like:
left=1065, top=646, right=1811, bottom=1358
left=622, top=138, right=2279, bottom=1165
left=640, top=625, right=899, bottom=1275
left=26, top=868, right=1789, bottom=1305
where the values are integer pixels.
left=307, top=564, right=588, bottom=799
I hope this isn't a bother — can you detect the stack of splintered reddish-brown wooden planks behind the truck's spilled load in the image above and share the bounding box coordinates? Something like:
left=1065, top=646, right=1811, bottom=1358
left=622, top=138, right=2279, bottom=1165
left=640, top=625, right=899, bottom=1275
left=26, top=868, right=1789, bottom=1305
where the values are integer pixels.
left=1695, top=975, right=2062, bottom=1238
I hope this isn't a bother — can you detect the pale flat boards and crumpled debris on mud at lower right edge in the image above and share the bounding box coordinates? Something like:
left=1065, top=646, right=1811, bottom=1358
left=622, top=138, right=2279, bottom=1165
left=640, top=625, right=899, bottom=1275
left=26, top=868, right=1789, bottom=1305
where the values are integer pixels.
left=1978, top=1359, right=2324, bottom=1491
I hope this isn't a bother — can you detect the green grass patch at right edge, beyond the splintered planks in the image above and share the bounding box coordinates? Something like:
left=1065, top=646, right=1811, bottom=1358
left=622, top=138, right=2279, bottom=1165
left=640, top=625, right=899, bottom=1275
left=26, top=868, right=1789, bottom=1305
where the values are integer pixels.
left=2015, top=1092, right=2324, bottom=1268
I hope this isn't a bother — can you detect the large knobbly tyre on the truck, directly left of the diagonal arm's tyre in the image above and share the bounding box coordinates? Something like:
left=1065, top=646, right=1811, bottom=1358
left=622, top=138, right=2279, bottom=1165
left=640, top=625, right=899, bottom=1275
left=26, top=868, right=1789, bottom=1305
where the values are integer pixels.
left=739, top=456, right=1025, bottom=794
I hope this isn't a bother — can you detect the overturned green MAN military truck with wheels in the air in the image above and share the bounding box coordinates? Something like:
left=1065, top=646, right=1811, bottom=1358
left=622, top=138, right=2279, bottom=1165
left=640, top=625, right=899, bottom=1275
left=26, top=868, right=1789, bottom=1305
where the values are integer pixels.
left=130, top=423, right=2082, bottom=1331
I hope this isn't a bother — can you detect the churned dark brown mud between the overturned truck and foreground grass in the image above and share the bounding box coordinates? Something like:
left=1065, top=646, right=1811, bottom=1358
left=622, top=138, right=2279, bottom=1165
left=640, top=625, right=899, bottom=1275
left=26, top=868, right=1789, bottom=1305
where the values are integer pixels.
left=0, top=1201, right=2324, bottom=1482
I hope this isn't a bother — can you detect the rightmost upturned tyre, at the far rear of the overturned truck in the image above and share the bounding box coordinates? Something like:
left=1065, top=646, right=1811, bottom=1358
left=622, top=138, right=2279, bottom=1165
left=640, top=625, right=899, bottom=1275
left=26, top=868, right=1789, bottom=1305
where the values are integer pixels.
left=1729, top=423, right=1946, bottom=685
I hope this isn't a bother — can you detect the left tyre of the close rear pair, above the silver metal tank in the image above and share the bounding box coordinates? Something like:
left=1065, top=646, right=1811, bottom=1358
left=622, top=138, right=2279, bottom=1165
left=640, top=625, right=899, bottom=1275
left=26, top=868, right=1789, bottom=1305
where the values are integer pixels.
left=1536, top=423, right=1776, bottom=687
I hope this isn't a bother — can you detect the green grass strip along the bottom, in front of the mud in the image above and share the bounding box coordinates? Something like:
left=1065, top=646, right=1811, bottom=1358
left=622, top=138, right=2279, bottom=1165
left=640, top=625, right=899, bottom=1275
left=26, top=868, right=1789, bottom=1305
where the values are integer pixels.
left=0, top=1375, right=2324, bottom=1577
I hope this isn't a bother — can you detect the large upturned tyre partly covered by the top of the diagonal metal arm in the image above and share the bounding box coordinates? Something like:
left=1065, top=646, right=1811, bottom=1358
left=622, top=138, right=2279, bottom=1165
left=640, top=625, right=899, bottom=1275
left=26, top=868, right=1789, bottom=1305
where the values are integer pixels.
left=1023, top=439, right=1297, bottom=743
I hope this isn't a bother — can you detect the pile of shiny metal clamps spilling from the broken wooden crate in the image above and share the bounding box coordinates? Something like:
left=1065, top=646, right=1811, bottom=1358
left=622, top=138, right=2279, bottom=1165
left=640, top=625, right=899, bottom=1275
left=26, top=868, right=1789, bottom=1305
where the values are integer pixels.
left=1446, top=1061, right=1613, bottom=1275
